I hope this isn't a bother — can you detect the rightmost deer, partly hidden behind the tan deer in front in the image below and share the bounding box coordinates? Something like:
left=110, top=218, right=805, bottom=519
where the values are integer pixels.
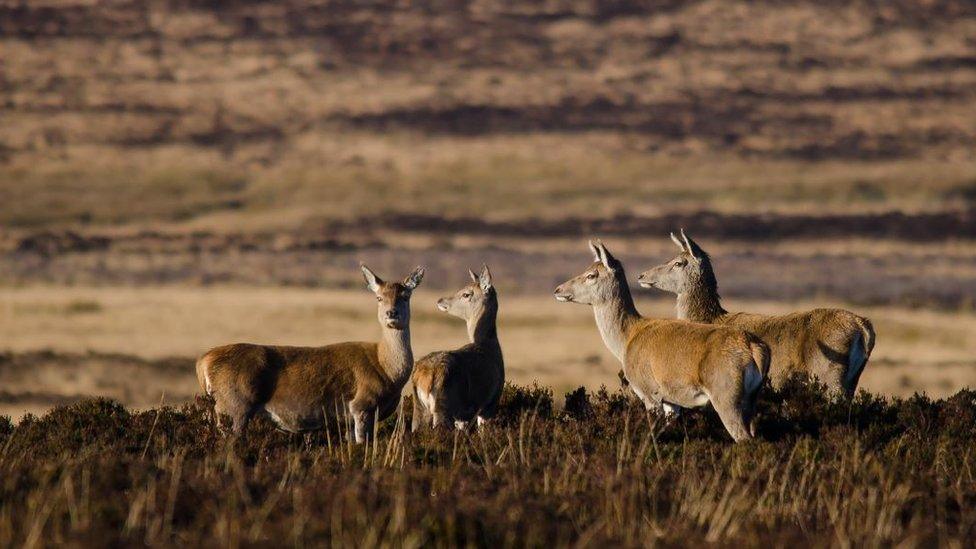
left=637, top=229, right=875, bottom=398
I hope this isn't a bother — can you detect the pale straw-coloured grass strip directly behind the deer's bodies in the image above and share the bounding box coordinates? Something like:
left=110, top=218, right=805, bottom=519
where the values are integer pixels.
left=0, top=287, right=976, bottom=418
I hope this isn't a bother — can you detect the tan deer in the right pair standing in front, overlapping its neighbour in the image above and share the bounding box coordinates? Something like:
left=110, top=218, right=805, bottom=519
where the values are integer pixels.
left=553, top=241, right=769, bottom=442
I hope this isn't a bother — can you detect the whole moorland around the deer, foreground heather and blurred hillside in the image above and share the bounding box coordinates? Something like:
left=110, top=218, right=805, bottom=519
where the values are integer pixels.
left=0, top=0, right=976, bottom=547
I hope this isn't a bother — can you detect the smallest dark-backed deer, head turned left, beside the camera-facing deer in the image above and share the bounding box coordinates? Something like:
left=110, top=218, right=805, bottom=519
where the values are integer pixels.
left=411, top=265, right=505, bottom=431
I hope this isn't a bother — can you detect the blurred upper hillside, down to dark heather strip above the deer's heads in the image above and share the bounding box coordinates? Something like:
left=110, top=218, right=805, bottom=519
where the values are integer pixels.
left=0, top=0, right=976, bottom=230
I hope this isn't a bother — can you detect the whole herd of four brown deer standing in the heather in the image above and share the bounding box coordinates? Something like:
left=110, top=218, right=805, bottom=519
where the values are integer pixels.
left=196, top=230, right=874, bottom=442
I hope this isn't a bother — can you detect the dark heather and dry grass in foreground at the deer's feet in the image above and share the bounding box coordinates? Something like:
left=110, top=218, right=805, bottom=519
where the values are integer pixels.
left=0, top=387, right=976, bottom=547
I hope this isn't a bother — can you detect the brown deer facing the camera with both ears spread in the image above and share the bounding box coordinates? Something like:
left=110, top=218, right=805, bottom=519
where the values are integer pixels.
left=196, top=265, right=424, bottom=443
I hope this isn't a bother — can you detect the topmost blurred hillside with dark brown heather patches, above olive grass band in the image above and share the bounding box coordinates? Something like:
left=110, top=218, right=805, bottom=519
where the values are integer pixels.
left=0, top=0, right=976, bottom=159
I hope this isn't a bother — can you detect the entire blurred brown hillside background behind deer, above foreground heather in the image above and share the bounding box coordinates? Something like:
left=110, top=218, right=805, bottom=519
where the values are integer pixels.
left=0, top=0, right=976, bottom=416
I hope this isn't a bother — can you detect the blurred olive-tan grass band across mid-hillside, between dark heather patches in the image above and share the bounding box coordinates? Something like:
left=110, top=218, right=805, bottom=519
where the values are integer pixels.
left=0, top=132, right=976, bottom=231
